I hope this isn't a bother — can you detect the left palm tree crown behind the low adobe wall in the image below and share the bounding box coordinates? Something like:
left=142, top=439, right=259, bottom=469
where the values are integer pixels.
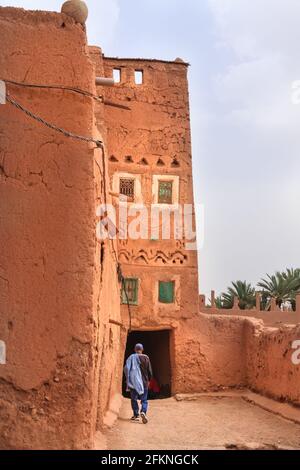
left=218, top=281, right=255, bottom=310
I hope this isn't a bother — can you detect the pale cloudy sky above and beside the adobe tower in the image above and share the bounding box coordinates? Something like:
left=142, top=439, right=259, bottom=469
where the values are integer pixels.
left=0, top=0, right=300, bottom=295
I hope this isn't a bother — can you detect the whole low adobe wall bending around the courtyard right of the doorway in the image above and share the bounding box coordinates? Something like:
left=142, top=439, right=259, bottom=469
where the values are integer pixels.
left=174, top=313, right=300, bottom=405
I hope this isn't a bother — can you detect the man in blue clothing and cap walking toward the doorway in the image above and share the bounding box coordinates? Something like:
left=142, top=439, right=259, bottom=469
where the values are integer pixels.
left=124, top=343, right=153, bottom=424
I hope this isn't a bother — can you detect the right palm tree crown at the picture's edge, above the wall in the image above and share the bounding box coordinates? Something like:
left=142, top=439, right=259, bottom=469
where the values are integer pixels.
left=257, top=268, right=300, bottom=310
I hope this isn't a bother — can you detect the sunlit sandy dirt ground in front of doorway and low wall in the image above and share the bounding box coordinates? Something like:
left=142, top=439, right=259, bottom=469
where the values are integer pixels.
left=106, top=397, right=300, bottom=450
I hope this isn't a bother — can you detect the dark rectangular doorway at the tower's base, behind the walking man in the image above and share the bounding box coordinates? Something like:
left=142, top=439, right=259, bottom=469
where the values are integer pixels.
left=123, top=330, right=171, bottom=399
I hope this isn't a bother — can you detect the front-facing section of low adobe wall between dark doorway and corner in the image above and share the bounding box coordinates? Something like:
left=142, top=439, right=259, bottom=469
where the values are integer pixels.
left=174, top=314, right=246, bottom=393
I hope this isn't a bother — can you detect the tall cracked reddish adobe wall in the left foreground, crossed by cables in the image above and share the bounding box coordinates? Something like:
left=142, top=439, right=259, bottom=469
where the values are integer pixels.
left=0, top=8, right=120, bottom=449
